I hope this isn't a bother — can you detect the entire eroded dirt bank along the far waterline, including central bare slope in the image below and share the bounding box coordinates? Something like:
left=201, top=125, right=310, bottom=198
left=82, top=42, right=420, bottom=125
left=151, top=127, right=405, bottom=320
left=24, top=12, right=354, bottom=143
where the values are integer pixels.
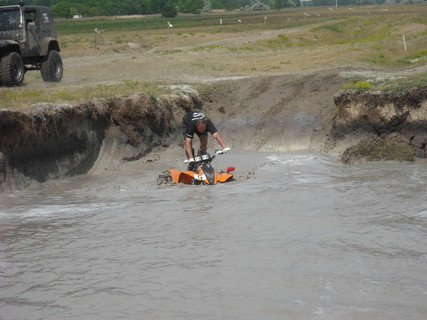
left=0, top=69, right=427, bottom=190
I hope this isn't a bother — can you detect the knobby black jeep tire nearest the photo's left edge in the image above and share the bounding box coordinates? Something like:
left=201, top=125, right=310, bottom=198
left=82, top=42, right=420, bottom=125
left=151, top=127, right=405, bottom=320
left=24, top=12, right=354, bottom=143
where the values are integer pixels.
left=0, top=52, right=25, bottom=87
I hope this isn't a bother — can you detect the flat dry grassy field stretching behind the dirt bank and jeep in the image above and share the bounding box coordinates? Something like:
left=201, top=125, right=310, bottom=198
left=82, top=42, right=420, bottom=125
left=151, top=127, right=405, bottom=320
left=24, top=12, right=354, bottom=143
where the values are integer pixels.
left=0, top=4, right=427, bottom=109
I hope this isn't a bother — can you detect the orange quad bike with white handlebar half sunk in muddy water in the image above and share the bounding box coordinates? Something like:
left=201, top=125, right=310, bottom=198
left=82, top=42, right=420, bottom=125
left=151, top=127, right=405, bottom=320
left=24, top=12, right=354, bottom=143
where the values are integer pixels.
left=169, top=150, right=235, bottom=185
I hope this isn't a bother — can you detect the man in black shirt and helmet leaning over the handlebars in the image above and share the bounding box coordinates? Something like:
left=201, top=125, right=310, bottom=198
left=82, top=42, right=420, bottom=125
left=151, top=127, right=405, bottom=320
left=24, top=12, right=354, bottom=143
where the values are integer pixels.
left=182, top=111, right=230, bottom=170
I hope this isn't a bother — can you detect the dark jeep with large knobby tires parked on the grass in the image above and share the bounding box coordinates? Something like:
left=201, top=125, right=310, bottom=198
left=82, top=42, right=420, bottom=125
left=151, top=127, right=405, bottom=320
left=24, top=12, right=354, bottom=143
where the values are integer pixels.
left=0, top=1, right=63, bottom=86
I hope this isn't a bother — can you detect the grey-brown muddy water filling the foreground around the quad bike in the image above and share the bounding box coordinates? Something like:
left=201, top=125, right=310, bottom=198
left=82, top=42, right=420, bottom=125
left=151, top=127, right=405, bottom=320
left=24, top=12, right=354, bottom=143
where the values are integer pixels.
left=0, top=152, right=427, bottom=320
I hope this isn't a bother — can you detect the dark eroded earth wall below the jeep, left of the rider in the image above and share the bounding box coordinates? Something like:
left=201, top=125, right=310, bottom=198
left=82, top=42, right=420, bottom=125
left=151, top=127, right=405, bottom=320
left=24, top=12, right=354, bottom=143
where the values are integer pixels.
left=0, top=94, right=199, bottom=191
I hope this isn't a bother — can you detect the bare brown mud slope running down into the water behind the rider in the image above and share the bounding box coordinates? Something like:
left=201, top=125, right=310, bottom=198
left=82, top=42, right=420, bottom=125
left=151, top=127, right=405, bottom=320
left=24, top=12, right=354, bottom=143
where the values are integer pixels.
left=205, top=70, right=348, bottom=151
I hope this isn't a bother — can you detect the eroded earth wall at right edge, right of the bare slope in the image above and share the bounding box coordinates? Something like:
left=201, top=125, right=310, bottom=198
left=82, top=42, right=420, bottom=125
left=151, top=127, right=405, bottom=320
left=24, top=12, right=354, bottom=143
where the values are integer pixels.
left=327, top=86, right=427, bottom=158
